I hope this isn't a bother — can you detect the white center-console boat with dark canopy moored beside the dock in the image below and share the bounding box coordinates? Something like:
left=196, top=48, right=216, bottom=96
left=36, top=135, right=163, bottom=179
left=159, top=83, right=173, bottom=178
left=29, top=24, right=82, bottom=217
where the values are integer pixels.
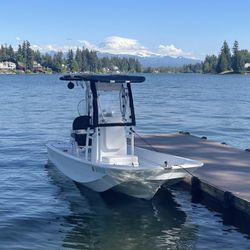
left=47, top=75, right=203, bottom=199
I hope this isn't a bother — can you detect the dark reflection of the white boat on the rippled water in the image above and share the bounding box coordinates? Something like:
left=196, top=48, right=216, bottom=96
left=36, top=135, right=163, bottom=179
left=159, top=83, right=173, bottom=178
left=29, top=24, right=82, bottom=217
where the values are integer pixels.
left=47, top=161, right=196, bottom=250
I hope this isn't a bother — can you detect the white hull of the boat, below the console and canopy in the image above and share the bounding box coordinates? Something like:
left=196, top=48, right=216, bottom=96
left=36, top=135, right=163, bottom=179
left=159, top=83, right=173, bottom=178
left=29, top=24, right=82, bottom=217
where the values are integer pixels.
left=47, top=144, right=200, bottom=199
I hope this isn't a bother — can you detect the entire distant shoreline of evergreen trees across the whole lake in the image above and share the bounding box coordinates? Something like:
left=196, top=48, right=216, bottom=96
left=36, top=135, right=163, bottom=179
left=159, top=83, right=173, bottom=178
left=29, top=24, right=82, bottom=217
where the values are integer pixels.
left=0, top=41, right=250, bottom=74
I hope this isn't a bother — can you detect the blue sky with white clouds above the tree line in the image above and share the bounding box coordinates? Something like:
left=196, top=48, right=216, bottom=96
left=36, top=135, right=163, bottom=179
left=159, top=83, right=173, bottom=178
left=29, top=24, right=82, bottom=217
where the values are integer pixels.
left=0, top=0, right=250, bottom=59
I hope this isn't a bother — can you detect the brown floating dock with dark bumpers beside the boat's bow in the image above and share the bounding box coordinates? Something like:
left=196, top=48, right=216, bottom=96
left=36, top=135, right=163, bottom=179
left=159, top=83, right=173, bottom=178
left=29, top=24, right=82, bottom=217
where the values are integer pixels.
left=135, top=132, right=250, bottom=215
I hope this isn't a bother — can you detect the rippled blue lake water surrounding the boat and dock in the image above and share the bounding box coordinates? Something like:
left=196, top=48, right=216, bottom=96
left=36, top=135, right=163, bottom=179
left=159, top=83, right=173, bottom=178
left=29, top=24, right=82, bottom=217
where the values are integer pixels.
left=0, top=74, right=250, bottom=250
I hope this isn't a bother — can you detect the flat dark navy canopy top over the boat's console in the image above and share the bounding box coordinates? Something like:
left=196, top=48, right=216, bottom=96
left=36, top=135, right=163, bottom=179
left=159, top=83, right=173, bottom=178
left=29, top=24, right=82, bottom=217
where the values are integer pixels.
left=60, top=74, right=145, bottom=83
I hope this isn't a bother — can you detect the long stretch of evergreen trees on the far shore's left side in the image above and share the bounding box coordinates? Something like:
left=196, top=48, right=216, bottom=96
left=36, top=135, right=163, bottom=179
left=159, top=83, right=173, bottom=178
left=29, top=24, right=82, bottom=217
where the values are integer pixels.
left=0, top=41, right=142, bottom=73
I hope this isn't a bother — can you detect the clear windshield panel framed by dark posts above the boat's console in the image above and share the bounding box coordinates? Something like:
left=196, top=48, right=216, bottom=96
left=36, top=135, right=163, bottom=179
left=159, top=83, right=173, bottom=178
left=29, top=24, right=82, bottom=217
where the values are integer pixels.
left=96, top=83, right=132, bottom=125
